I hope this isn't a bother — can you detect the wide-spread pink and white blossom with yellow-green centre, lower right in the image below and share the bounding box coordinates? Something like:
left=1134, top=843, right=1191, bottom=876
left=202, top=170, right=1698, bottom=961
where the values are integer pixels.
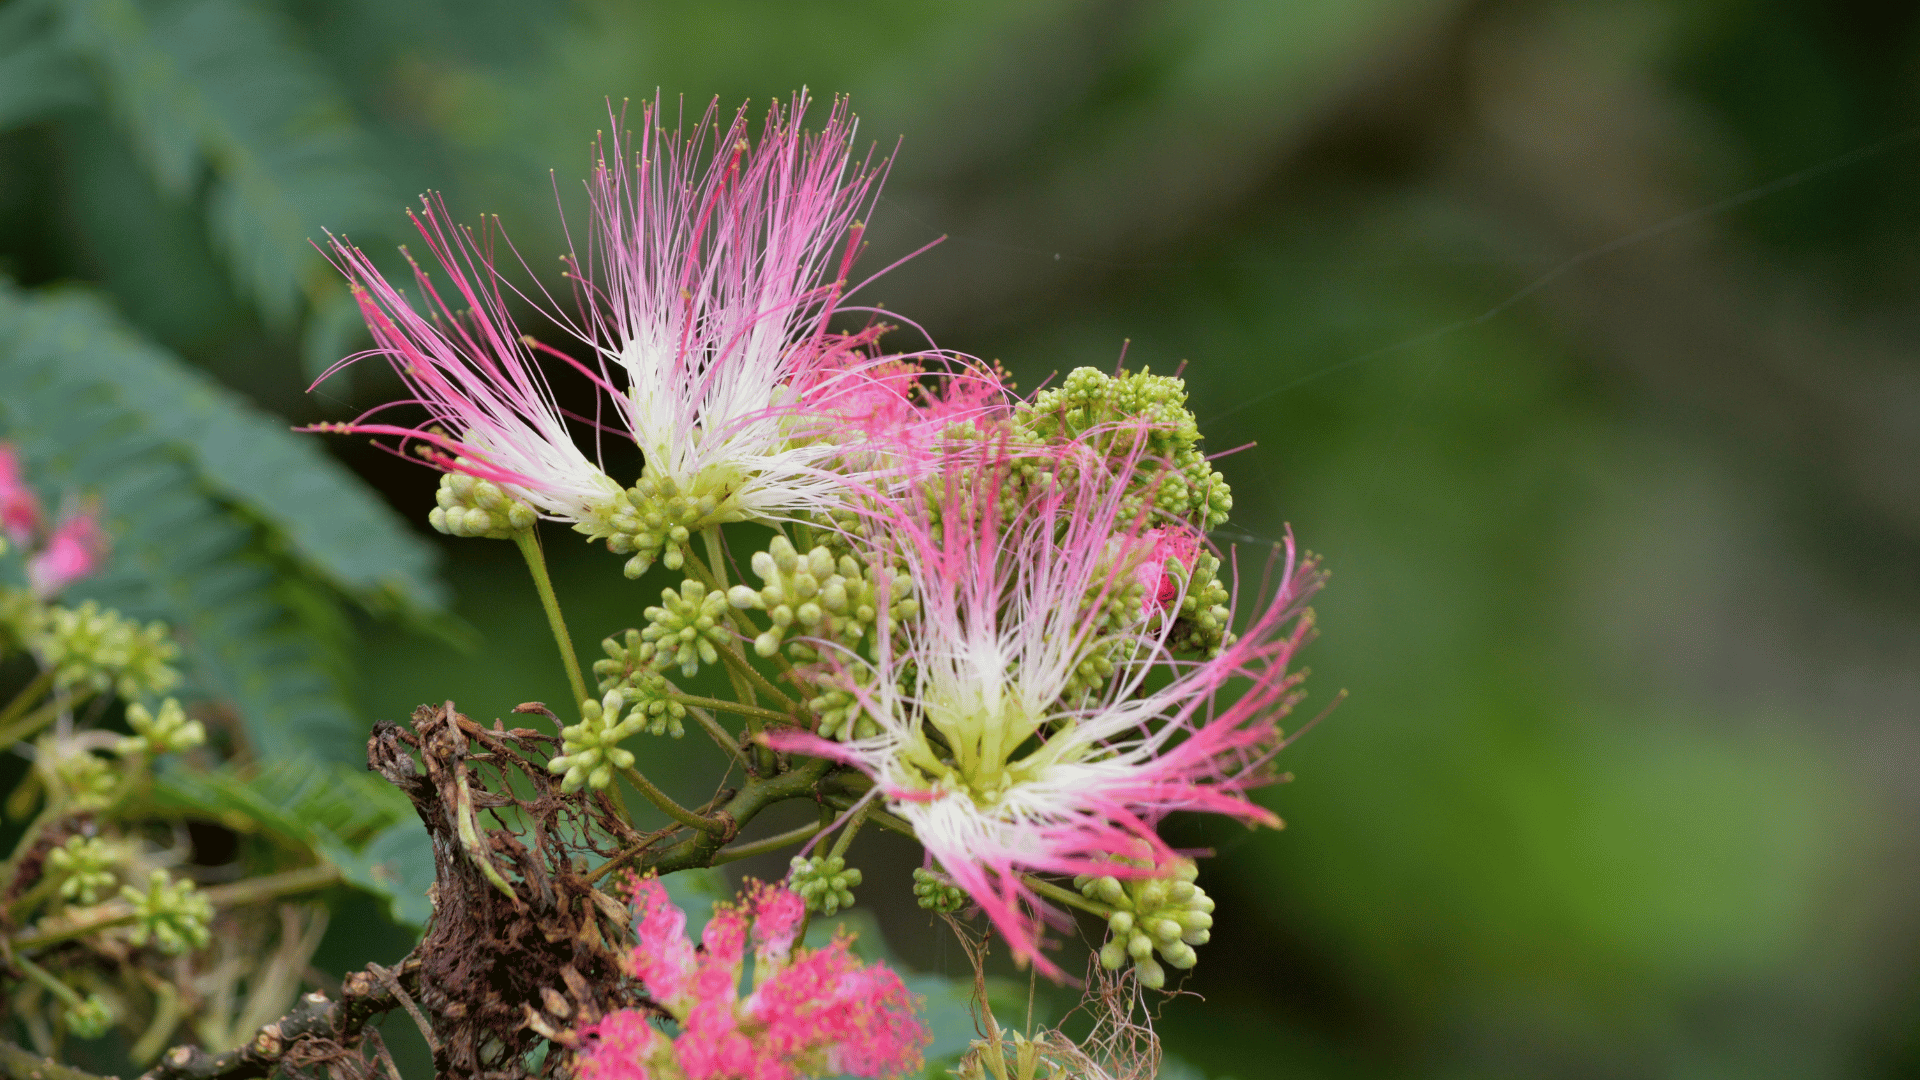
left=772, top=430, right=1321, bottom=978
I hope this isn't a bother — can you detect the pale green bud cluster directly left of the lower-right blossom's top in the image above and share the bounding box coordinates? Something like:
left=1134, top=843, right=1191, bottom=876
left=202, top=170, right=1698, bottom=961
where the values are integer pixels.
left=728, top=536, right=920, bottom=659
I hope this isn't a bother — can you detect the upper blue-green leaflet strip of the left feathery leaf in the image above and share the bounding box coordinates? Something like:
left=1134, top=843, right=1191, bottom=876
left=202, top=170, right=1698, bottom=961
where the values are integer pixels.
left=0, top=278, right=447, bottom=619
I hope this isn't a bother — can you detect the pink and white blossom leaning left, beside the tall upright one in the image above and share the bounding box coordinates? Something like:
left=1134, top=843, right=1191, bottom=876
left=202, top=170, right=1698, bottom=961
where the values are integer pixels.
left=307, top=198, right=624, bottom=523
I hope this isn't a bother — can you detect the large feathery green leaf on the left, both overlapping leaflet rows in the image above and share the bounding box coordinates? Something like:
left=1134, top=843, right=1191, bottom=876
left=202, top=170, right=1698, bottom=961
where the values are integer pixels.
left=0, top=276, right=444, bottom=759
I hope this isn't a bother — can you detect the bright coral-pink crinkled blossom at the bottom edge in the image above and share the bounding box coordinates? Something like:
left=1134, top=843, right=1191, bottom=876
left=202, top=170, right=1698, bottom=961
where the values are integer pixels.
left=574, top=878, right=929, bottom=1080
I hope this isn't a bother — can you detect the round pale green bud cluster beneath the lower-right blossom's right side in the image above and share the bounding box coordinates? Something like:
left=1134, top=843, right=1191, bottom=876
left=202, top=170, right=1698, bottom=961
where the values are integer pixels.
left=1073, top=859, right=1213, bottom=990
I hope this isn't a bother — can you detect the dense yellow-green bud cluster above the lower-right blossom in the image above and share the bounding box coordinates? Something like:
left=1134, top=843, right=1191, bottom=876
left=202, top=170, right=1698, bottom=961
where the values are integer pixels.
left=1016, top=367, right=1233, bottom=530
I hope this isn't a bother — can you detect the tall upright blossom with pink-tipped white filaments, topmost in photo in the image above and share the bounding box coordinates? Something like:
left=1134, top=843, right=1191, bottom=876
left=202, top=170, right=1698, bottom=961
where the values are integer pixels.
left=560, top=92, right=944, bottom=573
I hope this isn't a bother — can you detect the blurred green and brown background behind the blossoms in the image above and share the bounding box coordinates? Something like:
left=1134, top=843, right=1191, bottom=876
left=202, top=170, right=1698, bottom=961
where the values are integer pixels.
left=0, top=0, right=1920, bottom=1080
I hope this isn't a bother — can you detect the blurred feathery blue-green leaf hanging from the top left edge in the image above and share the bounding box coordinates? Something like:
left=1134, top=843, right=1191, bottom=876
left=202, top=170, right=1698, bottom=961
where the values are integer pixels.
left=60, top=0, right=399, bottom=325
